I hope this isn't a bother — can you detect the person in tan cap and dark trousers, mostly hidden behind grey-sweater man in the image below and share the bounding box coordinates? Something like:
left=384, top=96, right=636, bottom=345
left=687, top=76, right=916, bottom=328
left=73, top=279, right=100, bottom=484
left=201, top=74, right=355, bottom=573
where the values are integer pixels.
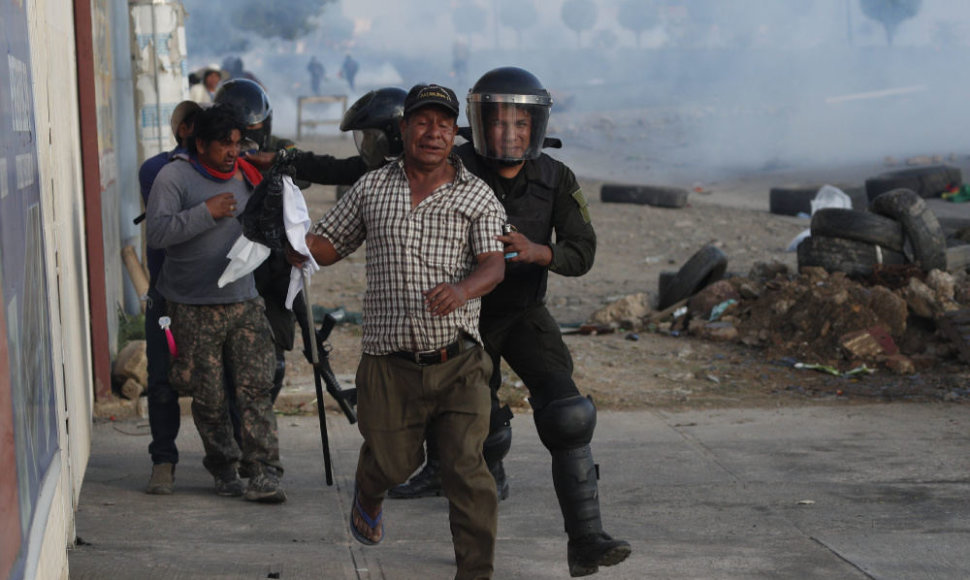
left=138, top=100, right=202, bottom=495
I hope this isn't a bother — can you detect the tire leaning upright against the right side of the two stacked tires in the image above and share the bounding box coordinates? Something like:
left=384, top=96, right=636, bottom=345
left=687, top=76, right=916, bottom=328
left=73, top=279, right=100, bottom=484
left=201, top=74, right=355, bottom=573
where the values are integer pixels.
left=869, top=189, right=946, bottom=272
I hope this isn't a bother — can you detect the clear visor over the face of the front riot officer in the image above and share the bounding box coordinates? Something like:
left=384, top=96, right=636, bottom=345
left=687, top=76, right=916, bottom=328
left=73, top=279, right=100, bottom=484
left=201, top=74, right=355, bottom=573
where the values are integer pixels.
left=468, top=94, right=552, bottom=163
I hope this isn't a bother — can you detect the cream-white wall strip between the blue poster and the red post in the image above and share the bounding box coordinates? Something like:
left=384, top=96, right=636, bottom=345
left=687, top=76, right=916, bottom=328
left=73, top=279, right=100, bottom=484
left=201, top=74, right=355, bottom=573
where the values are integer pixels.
left=27, top=0, right=94, bottom=578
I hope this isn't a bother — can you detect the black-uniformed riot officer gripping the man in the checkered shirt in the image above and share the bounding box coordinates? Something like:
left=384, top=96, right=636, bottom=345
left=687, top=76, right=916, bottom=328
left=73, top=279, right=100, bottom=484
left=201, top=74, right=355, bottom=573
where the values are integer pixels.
left=392, top=67, right=631, bottom=576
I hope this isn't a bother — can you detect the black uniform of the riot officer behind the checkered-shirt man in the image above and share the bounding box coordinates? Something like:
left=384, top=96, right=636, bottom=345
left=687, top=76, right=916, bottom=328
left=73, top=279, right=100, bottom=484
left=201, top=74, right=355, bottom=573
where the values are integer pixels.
left=458, top=143, right=596, bottom=410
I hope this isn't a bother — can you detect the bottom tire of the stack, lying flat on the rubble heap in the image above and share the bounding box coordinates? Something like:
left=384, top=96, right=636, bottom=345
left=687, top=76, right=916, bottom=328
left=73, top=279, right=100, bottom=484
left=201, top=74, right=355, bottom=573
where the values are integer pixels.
left=798, top=236, right=906, bottom=277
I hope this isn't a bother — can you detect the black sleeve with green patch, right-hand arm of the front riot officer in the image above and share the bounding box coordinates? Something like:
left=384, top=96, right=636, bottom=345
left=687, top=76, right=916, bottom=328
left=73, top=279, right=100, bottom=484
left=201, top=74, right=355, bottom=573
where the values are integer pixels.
left=549, top=167, right=596, bottom=276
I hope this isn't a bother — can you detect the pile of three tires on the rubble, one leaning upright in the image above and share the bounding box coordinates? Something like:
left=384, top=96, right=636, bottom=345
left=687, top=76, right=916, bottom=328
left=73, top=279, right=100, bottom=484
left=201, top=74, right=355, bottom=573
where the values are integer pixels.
left=798, top=189, right=947, bottom=277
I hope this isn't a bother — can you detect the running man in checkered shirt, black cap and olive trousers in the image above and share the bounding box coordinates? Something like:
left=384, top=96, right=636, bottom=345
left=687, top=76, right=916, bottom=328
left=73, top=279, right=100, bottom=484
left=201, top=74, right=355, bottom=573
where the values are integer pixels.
left=291, top=85, right=506, bottom=579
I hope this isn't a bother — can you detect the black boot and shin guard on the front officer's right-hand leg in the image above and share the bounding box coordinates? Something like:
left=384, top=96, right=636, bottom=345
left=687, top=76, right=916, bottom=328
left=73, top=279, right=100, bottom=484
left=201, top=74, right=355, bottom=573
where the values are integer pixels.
left=552, top=445, right=631, bottom=577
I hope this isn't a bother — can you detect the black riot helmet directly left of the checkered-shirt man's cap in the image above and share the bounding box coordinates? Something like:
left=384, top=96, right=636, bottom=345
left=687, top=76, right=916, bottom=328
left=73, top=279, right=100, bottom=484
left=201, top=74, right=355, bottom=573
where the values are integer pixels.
left=340, top=87, right=407, bottom=169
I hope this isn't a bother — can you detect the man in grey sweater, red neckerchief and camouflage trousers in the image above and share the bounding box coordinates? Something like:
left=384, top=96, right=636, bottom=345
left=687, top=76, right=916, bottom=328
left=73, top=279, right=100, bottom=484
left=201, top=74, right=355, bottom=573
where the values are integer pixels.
left=146, top=105, right=286, bottom=503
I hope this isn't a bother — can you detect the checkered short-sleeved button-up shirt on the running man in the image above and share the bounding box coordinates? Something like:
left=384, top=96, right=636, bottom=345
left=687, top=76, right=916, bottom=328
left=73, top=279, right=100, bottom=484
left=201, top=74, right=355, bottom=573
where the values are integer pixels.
left=313, top=155, right=506, bottom=355
